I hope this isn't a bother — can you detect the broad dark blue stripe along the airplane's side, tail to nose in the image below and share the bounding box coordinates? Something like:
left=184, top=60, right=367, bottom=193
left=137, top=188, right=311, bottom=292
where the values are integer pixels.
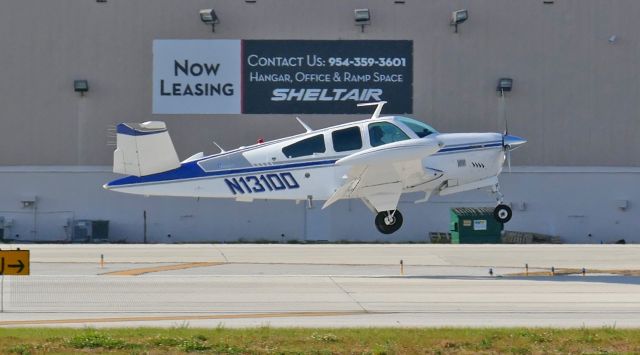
left=107, top=142, right=502, bottom=187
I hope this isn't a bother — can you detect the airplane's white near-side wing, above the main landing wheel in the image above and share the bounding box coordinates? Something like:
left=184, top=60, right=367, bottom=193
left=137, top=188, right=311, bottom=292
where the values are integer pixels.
left=322, top=138, right=442, bottom=212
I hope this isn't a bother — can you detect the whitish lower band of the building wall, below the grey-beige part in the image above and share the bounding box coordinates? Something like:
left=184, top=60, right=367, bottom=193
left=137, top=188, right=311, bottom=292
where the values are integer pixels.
left=0, top=167, right=640, bottom=243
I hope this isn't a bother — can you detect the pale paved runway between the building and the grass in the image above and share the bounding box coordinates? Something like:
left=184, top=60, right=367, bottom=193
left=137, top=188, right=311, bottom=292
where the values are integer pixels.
left=0, top=244, right=640, bottom=327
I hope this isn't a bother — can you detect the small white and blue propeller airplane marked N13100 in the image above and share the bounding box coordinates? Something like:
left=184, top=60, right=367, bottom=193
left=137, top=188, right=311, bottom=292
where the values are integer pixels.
left=104, top=101, right=526, bottom=234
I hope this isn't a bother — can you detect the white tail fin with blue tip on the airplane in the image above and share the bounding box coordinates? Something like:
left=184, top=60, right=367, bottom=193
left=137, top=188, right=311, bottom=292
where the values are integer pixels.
left=113, top=121, right=180, bottom=176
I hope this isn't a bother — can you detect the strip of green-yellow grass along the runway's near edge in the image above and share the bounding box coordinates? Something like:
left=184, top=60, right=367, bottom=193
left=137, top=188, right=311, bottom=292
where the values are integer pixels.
left=0, top=323, right=640, bottom=355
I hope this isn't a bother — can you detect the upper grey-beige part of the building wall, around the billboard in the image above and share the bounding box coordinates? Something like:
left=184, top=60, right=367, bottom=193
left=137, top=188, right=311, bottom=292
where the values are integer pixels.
left=0, top=0, right=640, bottom=166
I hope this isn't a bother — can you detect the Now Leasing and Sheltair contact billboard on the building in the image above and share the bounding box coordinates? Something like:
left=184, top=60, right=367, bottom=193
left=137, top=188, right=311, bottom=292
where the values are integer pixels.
left=153, top=40, right=413, bottom=114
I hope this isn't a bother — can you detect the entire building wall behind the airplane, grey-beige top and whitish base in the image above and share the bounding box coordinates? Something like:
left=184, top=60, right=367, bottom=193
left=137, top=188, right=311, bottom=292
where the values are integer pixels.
left=0, top=0, right=640, bottom=242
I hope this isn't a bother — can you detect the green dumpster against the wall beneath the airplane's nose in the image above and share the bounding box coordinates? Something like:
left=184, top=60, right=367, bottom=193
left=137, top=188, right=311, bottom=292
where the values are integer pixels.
left=450, top=207, right=504, bottom=244
